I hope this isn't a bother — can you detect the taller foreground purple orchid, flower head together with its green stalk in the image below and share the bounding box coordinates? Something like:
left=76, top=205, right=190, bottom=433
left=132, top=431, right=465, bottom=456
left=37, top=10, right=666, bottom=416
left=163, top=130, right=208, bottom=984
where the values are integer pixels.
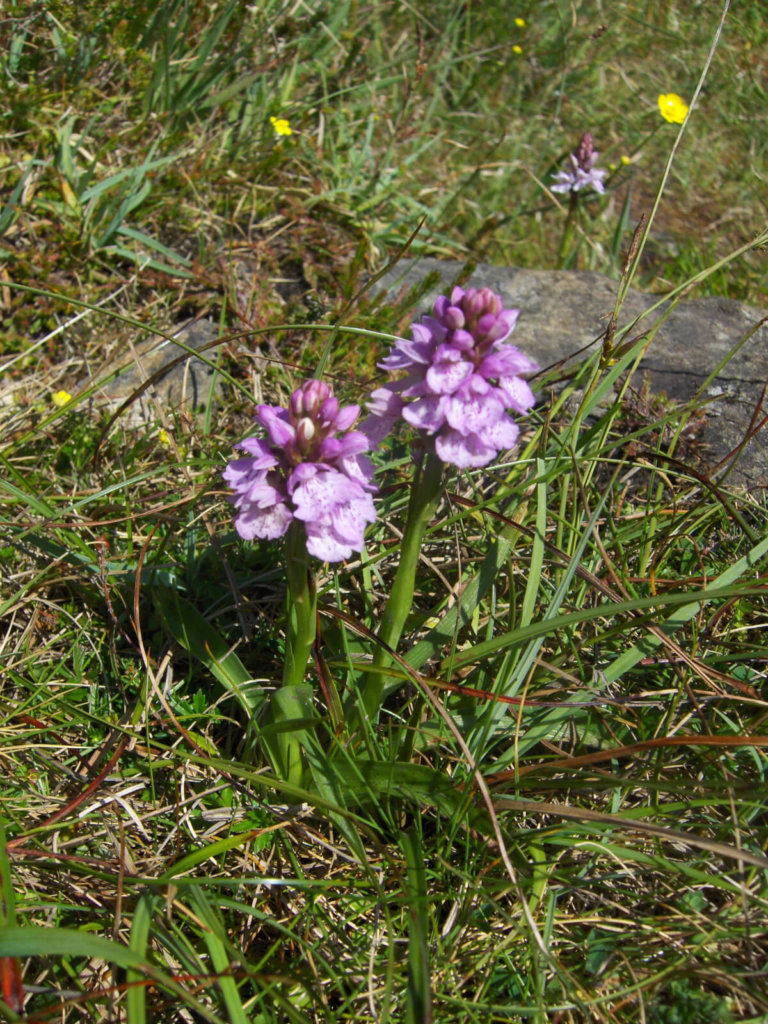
left=360, top=288, right=539, bottom=720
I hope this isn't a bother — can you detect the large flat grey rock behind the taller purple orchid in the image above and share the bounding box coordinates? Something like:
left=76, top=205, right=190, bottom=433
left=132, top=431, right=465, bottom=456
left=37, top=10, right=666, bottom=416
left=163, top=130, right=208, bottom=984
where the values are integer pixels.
left=373, top=259, right=768, bottom=489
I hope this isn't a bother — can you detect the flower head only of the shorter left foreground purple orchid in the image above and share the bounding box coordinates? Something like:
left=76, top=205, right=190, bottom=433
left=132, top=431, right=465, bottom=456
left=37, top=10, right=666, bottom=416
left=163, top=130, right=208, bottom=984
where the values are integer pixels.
left=223, top=380, right=377, bottom=562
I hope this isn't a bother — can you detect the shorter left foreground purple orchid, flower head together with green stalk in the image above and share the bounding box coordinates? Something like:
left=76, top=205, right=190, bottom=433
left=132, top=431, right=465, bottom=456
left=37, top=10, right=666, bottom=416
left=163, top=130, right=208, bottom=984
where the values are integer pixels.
left=223, top=380, right=376, bottom=784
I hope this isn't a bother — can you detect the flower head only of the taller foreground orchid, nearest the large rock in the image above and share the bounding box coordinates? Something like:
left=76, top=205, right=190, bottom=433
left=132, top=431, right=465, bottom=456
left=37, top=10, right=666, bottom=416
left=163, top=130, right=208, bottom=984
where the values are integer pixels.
left=360, top=288, right=539, bottom=469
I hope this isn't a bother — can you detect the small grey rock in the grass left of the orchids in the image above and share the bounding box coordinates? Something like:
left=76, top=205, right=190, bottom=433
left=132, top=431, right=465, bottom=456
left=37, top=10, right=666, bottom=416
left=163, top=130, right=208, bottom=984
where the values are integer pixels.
left=95, top=321, right=225, bottom=426
